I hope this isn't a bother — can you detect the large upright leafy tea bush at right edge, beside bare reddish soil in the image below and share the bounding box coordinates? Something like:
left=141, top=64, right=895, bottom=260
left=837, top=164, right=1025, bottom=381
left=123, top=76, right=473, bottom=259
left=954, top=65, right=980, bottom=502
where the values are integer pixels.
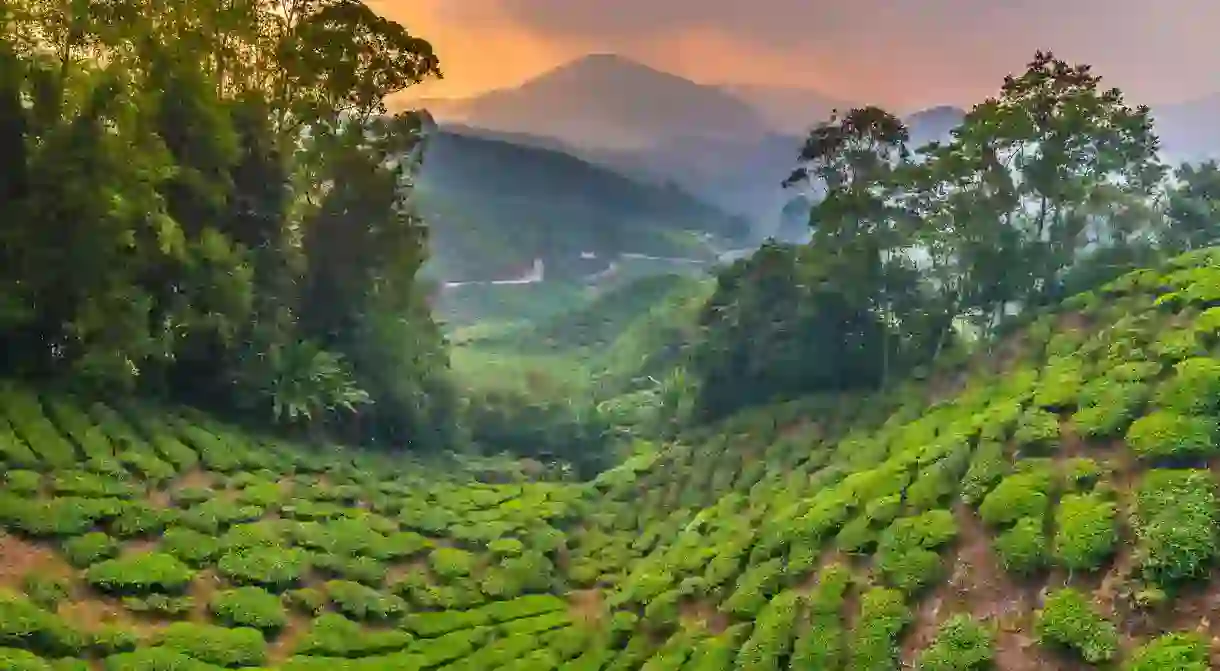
left=1133, top=468, right=1220, bottom=584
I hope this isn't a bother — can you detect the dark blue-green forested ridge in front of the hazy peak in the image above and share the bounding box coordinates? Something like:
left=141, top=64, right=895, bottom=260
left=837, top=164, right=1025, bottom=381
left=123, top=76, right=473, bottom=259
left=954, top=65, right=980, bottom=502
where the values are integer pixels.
left=418, top=131, right=744, bottom=281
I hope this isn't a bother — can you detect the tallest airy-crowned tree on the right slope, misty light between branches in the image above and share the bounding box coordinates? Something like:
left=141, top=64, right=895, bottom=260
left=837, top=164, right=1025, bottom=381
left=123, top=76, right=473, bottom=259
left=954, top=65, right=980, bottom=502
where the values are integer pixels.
left=949, top=51, right=1164, bottom=304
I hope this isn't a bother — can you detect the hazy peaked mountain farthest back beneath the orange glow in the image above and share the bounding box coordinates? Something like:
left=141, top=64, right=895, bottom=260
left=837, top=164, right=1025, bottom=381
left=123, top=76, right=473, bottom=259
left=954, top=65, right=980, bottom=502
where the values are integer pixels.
left=417, top=55, right=976, bottom=231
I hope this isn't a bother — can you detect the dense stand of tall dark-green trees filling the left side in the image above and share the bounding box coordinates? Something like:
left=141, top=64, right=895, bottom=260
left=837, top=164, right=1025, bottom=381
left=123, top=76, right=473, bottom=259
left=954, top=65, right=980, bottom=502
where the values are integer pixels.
left=0, top=0, right=456, bottom=448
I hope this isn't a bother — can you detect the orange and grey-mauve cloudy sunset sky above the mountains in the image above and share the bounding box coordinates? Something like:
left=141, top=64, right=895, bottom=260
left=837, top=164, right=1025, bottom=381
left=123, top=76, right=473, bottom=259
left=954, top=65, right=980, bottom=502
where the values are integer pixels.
left=367, top=0, right=1220, bottom=109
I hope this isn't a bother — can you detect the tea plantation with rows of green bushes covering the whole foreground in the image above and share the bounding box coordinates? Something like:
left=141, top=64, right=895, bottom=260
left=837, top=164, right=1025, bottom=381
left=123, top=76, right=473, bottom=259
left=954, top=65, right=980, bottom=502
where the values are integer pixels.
left=11, top=251, right=1220, bottom=671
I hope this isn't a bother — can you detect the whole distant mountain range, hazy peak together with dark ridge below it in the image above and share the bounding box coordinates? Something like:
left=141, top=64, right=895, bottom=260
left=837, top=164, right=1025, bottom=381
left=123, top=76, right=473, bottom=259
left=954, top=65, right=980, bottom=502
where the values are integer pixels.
left=414, top=54, right=1220, bottom=278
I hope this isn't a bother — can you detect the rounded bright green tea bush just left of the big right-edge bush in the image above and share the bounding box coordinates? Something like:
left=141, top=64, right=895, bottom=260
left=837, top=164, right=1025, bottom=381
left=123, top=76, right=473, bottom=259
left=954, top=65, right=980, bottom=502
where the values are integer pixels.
left=1054, top=494, right=1119, bottom=571
